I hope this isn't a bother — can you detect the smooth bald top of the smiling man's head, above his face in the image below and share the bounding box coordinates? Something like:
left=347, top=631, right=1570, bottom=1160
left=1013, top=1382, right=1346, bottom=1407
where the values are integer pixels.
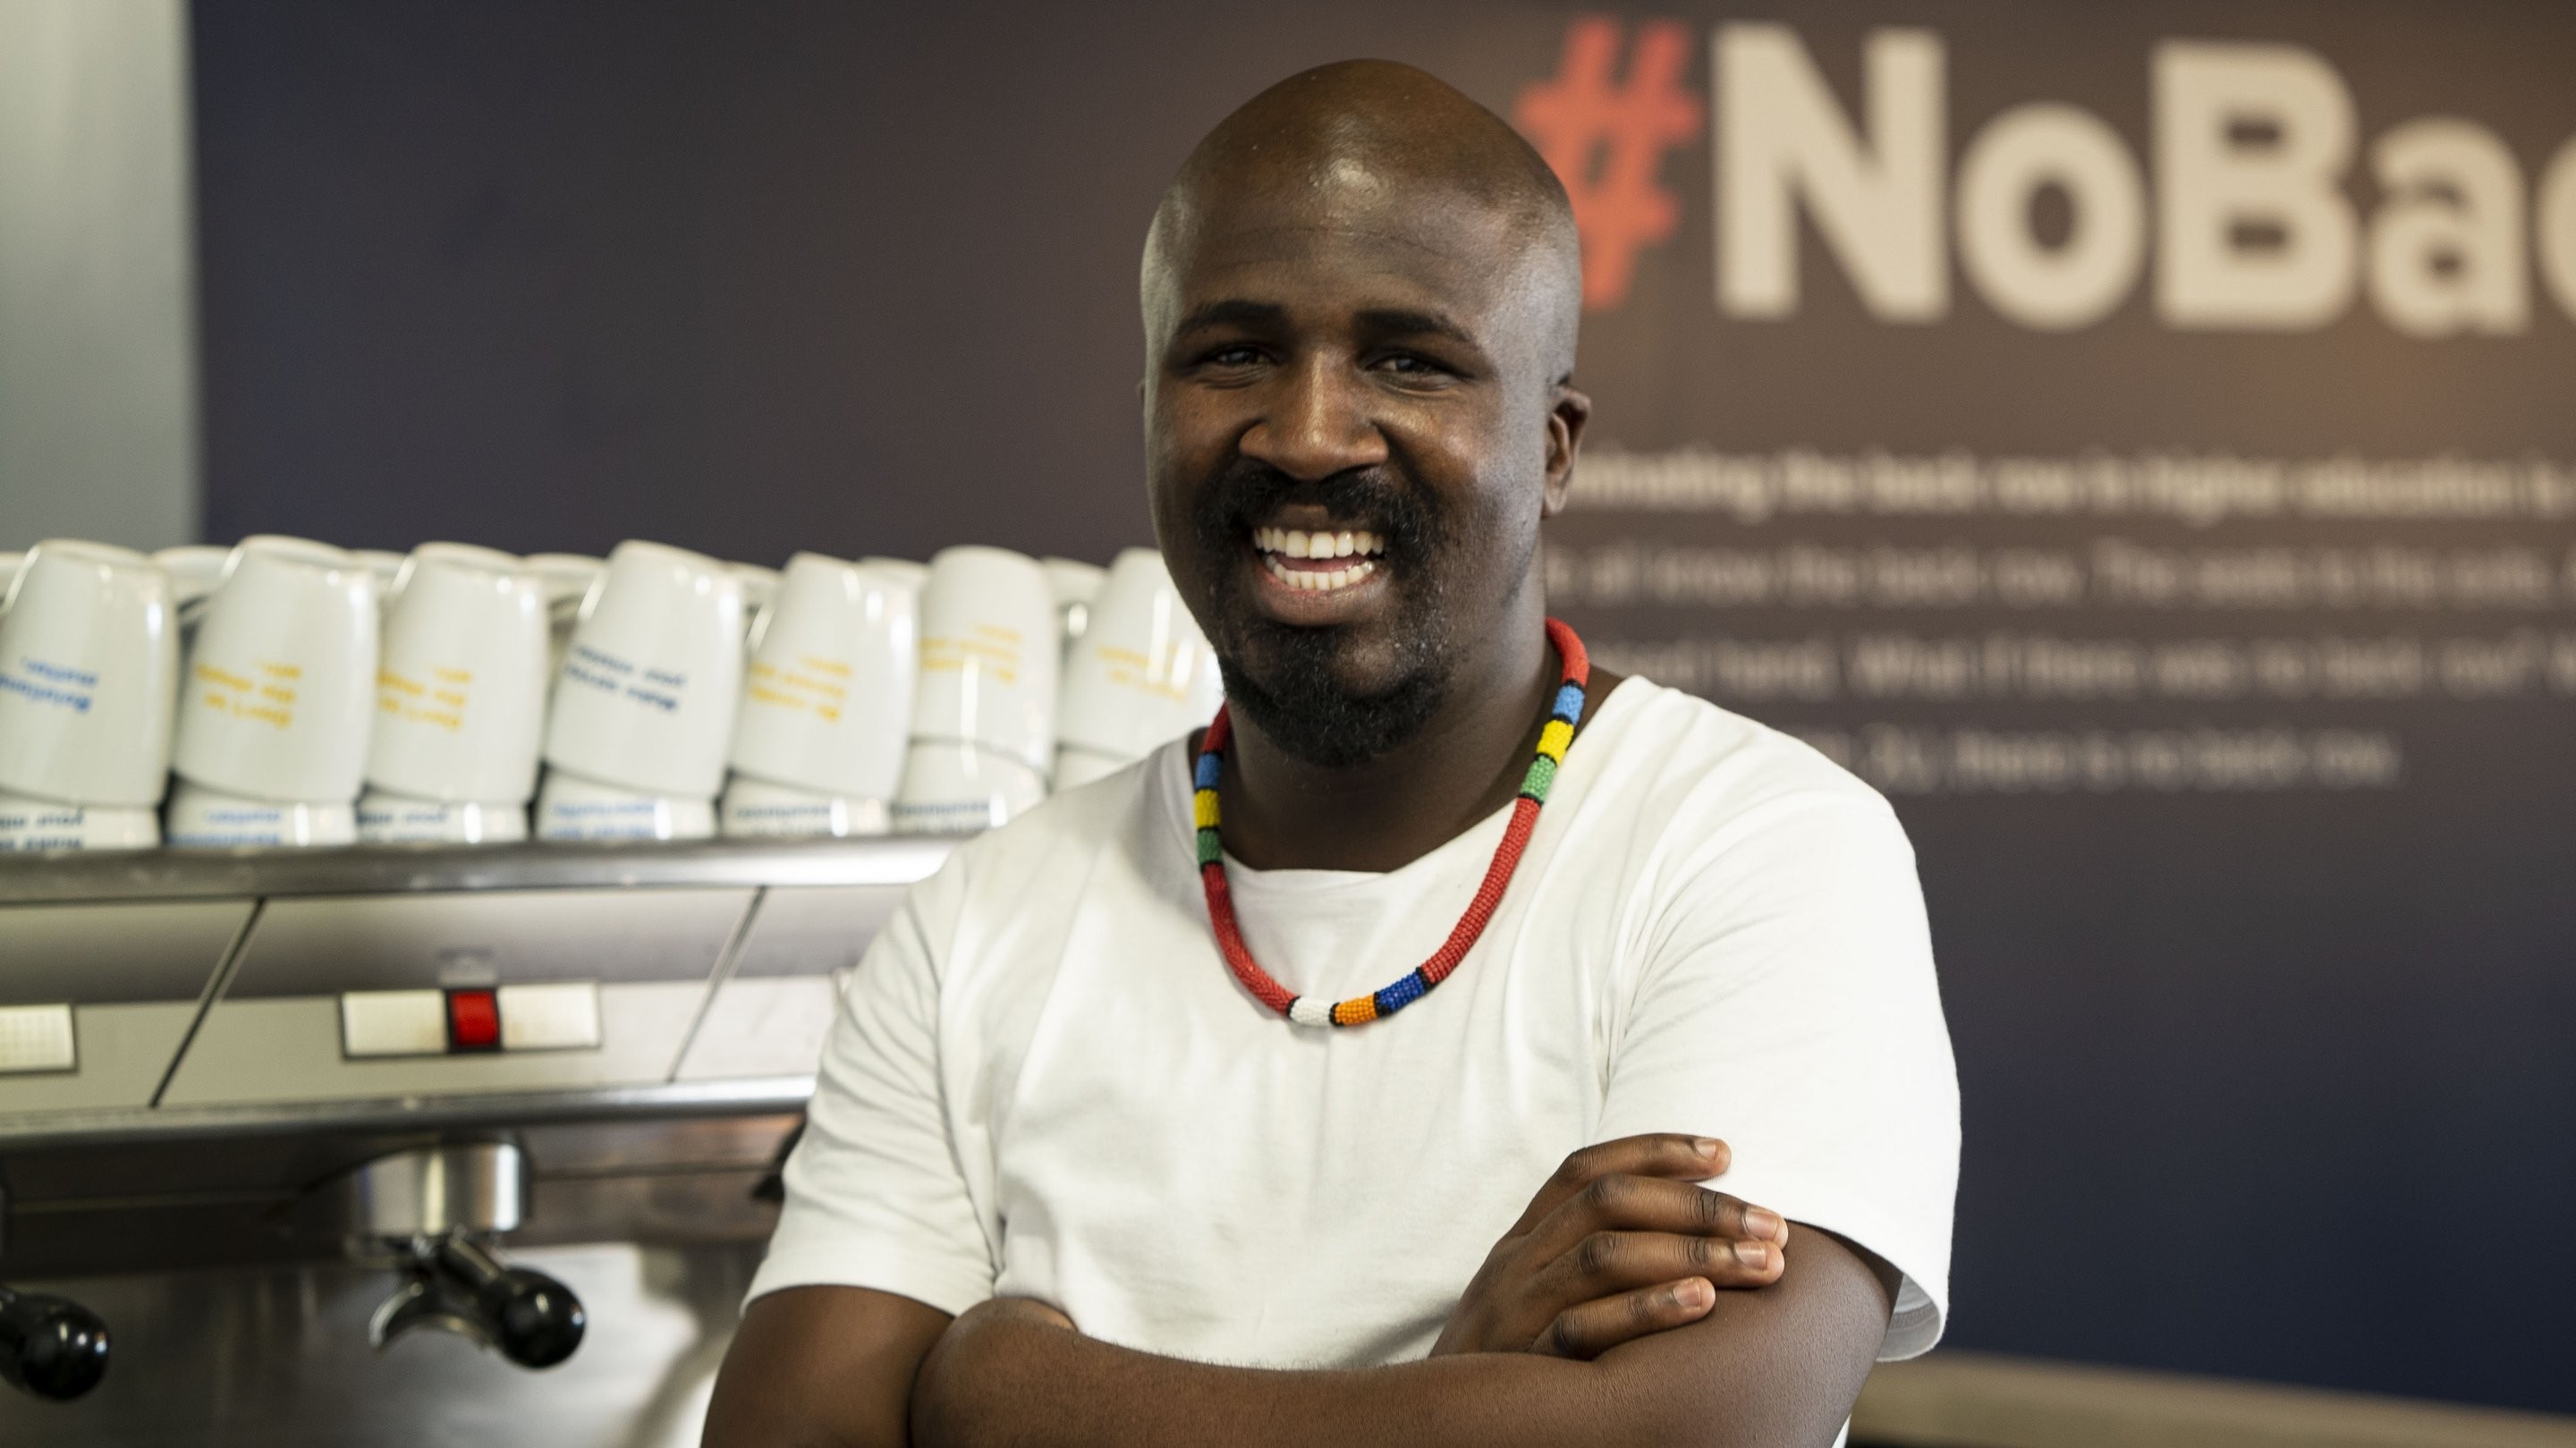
left=1141, top=59, right=1581, bottom=381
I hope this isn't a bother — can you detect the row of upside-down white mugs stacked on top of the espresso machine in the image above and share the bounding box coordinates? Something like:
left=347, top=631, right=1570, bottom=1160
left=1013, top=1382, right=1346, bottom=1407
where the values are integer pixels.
left=0, top=536, right=1221, bottom=851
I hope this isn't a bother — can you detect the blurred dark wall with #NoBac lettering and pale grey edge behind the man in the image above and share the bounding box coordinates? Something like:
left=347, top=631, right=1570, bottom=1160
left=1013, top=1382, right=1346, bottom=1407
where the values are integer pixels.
left=0, top=0, right=2576, bottom=1443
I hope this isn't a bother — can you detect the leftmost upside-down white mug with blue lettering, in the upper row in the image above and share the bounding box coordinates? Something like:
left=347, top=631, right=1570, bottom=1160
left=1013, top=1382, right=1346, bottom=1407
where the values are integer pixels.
left=0, top=538, right=178, bottom=811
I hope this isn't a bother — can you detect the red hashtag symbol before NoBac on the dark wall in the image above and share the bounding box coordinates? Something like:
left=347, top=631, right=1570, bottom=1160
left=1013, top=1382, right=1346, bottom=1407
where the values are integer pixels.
left=1513, top=15, right=1700, bottom=307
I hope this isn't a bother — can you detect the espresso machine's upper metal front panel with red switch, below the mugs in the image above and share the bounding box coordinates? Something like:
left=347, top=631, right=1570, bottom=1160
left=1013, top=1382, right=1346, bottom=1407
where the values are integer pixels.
left=0, top=837, right=953, bottom=1118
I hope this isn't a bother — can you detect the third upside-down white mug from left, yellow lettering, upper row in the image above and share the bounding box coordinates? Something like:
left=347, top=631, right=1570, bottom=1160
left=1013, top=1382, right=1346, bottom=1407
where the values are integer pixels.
left=360, top=544, right=547, bottom=803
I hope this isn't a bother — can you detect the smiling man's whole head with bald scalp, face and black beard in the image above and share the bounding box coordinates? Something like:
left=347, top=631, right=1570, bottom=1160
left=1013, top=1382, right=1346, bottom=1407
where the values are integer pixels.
left=1141, top=62, right=1592, bottom=767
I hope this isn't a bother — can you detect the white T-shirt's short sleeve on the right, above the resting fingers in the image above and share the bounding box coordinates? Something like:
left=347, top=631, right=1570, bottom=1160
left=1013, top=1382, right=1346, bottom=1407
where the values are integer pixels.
left=1599, top=786, right=1958, bottom=1360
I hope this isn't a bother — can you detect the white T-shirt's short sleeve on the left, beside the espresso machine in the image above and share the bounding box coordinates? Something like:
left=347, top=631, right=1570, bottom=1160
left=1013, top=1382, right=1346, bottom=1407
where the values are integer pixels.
left=750, top=874, right=995, bottom=1314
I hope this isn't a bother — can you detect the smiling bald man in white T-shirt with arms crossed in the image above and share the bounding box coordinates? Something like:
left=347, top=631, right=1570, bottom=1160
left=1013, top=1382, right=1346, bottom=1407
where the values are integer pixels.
left=708, top=62, right=1958, bottom=1448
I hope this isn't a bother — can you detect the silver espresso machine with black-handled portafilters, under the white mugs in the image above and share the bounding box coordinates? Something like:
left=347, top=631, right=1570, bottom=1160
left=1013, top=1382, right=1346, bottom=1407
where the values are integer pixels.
left=0, top=837, right=953, bottom=1448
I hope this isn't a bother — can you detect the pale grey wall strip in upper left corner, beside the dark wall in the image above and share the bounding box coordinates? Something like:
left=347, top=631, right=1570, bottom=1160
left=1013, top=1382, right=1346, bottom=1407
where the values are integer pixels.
left=0, top=0, right=199, bottom=549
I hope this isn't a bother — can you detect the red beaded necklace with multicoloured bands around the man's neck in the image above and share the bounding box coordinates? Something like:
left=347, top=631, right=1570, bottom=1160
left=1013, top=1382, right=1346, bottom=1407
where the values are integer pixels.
left=1191, top=618, right=1592, bottom=1026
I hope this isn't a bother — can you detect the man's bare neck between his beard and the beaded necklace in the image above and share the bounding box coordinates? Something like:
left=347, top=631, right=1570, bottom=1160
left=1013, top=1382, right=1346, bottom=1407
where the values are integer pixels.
left=1218, top=607, right=1610, bottom=874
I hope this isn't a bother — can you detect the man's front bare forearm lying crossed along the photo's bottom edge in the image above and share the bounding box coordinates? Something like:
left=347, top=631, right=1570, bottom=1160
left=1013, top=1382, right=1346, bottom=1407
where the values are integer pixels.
left=912, top=1221, right=1885, bottom=1448
